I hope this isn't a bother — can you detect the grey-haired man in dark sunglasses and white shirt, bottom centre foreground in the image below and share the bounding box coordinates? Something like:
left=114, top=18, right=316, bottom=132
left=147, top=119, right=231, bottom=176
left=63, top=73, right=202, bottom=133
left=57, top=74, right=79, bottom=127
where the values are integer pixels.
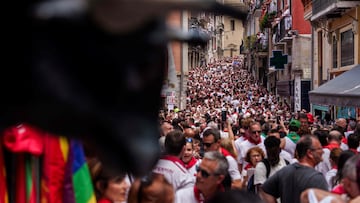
left=175, top=151, right=229, bottom=203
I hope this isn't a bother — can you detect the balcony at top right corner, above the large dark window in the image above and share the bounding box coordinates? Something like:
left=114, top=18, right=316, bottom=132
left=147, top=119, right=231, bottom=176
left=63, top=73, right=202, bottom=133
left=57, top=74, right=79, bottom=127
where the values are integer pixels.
left=311, top=0, right=360, bottom=21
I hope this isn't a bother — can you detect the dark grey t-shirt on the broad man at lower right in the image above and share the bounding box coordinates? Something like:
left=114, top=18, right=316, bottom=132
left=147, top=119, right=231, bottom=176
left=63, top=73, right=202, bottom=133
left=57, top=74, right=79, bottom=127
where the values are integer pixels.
left=262, top=163, right=328, bottom=203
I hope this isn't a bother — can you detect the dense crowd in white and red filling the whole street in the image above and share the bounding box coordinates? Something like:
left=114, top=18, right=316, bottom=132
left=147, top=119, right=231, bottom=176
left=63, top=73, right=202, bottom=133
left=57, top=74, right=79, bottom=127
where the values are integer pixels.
left=89, top=57, right=360, bottom=203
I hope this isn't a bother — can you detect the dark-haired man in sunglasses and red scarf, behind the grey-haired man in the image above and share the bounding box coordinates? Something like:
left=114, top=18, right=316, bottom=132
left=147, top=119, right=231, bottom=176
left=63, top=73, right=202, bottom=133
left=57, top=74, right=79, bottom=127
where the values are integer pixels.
left=203, top=128, right=242, bottom=189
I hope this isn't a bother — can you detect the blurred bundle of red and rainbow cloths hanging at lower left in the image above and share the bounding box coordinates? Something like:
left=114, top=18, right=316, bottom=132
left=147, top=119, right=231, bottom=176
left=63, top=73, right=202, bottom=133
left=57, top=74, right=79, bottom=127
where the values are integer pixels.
left=0, top=124, right=96, bottom=203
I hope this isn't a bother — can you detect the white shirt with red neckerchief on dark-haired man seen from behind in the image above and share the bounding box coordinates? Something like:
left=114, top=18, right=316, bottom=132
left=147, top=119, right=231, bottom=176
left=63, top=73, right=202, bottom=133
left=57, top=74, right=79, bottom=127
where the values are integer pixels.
left=153, top=156, right=195, bottom=191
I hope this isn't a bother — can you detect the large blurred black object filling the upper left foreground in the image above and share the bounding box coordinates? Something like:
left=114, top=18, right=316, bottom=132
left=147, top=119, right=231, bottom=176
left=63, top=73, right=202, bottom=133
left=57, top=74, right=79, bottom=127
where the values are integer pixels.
left=0, top=0, right=245, bottom=176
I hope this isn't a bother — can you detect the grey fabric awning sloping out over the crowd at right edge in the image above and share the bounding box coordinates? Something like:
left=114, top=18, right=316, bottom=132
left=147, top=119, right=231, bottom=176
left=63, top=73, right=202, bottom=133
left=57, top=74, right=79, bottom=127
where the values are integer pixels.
left=309, top=64, right=360, bottom=107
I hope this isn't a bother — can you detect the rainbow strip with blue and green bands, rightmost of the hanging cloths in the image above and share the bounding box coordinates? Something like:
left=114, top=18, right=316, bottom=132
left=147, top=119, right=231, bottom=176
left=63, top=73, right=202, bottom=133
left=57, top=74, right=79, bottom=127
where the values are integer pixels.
left=63, top=140, right=96, bottom=203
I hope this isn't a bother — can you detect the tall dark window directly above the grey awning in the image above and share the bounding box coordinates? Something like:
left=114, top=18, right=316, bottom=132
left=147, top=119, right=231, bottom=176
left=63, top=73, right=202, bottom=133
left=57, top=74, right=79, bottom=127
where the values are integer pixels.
left=340, top=29, right=355, bottom=66
